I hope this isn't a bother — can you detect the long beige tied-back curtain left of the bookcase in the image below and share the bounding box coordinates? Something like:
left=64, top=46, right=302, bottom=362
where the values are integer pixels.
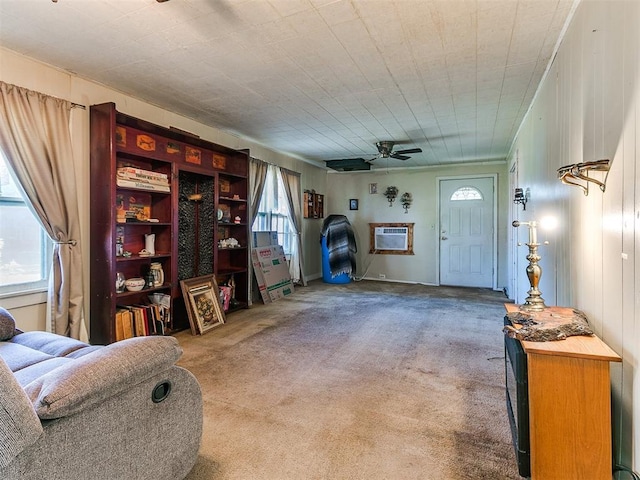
left=0, top=82, right=87, bottom=340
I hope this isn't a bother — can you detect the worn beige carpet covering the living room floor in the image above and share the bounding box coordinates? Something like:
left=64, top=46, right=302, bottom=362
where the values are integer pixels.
left=175, top=281, right=520, bottom=480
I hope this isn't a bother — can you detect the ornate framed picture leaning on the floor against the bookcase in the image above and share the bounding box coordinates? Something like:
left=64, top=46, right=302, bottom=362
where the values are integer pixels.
left=180, top=275, right=226, bottom=335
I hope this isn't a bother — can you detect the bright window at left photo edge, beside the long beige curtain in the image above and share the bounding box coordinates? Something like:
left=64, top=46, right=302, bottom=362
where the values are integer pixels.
left=0, top=152, right=51, bottom=294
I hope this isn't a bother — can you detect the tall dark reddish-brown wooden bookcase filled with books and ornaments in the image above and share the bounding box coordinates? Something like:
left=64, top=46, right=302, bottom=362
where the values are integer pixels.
left=90, top=103, right=249, bottom=343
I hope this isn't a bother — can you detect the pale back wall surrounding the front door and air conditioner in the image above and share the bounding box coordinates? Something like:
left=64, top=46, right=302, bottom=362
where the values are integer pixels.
left=325, top=163, right=510, bottom=289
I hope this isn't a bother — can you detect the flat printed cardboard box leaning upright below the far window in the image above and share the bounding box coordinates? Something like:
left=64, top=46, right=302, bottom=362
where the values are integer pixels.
left=251, top=245, right=294, bottom=303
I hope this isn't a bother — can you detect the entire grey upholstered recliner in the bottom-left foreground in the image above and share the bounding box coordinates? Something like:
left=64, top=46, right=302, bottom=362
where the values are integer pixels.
left=0, top=309, right=202, bottom=480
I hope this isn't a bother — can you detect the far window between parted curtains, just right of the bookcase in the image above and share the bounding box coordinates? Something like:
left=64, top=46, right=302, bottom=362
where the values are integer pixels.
left=251, top=165, right=296, bottom=257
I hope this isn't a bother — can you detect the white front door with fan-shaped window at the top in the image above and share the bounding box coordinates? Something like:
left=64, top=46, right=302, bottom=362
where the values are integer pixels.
left=440, top=177, right=494, bottom=288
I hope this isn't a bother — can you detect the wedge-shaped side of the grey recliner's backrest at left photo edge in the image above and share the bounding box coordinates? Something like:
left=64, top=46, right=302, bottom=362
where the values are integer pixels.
left=0, top=357, right=42, bottom=470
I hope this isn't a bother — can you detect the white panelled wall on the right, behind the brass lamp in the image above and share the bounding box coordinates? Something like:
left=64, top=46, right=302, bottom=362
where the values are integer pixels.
left=510, top=1, right=640, bottom=471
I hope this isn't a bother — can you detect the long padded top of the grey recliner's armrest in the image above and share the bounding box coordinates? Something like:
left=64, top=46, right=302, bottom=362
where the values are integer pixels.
left=24, top=337, right=182, bottom=419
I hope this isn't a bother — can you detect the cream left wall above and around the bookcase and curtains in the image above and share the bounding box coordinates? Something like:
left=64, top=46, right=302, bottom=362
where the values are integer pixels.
left=0, top=48, right=326, bottom=330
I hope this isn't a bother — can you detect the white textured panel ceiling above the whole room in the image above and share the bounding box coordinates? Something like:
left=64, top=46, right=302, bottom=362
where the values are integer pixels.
left=0, top=0, right=574, bottom=167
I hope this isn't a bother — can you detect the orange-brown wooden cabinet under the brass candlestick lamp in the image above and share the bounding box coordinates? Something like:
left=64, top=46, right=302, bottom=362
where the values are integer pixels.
left=505, top=304, right=621, bottom=480
